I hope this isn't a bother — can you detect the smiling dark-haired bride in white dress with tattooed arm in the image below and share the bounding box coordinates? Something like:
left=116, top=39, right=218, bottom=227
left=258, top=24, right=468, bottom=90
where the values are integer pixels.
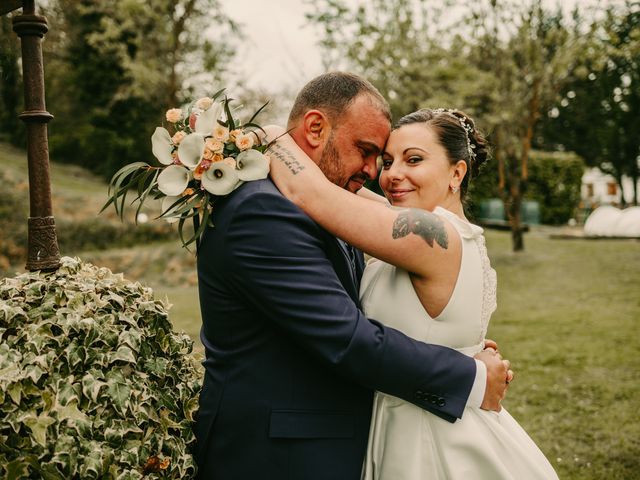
left=271, top=109, right=557, bottom=480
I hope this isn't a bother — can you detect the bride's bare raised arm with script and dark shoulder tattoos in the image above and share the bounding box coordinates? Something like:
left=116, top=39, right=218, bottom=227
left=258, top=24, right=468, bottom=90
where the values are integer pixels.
left=268, top=135, right=460, bottom=277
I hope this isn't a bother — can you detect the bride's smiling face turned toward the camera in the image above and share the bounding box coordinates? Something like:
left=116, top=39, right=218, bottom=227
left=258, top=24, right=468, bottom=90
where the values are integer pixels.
left=380, top=123, right=455, bottom=210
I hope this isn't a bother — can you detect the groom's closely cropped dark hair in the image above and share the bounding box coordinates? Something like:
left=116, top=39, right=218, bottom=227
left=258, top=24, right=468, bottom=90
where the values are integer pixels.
left=287, top=72, right=391, bottom=128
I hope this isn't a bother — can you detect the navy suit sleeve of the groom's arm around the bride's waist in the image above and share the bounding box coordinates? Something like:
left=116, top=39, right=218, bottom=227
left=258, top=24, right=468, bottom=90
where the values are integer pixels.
left=216, top=192, right=476, bottom=422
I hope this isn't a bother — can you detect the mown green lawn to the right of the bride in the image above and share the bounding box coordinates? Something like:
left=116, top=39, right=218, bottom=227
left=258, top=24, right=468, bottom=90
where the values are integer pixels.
left=487, top=232, right=640, bottom=480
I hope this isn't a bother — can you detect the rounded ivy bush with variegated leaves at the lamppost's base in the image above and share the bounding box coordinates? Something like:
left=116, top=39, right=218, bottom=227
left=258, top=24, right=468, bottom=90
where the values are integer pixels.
left=0, top=257, right=200, bottom=480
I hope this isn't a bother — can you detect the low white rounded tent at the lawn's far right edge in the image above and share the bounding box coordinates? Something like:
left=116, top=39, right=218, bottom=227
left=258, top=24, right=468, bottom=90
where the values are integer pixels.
left=584, top=205, right=640, bottom=238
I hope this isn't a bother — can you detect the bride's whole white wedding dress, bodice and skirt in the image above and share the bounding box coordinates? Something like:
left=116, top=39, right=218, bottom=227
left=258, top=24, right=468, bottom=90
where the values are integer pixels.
left=360, top=207, right=558, bottom=480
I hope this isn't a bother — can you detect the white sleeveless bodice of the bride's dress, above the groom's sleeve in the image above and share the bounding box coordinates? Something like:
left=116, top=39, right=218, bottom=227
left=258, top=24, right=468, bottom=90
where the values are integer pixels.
left=360, top=207, right=496, bottom=354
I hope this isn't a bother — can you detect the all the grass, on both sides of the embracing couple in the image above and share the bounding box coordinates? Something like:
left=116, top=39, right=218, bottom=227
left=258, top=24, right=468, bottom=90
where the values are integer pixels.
left=0, top=144, right=640, bottom=480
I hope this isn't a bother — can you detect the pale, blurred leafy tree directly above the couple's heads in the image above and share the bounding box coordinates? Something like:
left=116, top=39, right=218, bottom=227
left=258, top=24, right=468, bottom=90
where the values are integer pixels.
left=307, top=0, right=480, bottom=119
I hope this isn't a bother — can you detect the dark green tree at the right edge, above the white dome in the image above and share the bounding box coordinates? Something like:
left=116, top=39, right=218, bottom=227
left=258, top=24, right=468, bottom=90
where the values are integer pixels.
left=536, top=2, right=640, bottom=205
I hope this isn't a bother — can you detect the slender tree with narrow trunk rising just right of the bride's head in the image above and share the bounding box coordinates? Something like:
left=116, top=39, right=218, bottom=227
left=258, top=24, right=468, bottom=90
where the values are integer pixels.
left=460, top=0, right=588, bottom=251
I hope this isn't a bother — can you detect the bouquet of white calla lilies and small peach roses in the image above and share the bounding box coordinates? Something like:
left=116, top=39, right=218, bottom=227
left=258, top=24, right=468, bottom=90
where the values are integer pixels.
left=101, top=89, right=269, bottom=247
